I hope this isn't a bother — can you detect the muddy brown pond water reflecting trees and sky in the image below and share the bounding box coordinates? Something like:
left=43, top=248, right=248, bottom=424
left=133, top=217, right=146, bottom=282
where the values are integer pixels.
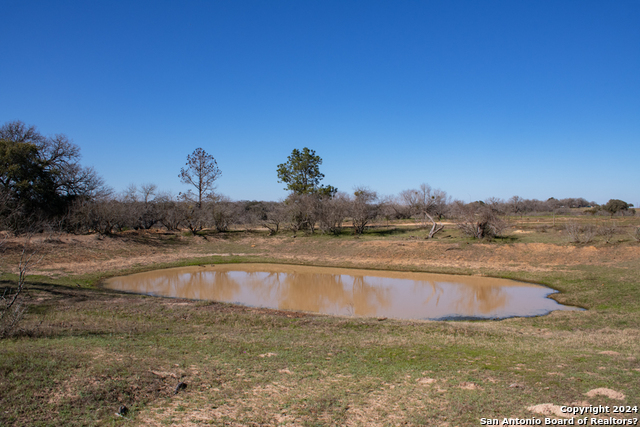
left=105, top=264, right=575, bottom=319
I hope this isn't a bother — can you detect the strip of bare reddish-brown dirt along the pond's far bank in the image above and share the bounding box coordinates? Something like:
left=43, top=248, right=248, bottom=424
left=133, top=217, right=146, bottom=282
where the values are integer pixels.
left=5, top=230, right=640, bottom=276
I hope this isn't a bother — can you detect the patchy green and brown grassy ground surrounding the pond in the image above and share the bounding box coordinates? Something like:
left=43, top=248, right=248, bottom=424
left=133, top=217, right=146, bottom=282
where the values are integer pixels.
left=0, top=217, right=640, bottom=426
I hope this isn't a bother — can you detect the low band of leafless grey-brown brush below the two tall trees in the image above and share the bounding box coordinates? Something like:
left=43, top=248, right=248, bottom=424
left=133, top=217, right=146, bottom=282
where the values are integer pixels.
left=59, top=190, right=635, bottom=237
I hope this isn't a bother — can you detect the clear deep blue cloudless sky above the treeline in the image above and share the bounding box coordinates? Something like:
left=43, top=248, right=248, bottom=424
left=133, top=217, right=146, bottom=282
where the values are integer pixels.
left=0, top=0, right=640, bottom=204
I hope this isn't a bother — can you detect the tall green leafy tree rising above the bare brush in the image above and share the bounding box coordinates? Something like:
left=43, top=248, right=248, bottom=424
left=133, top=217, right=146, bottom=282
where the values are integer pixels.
left=278, top=147, right=338, bottom=196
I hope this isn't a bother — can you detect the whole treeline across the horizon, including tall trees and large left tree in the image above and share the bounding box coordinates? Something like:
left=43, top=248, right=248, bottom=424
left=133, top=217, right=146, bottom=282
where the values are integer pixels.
left=0, top=122, right=635, bottom=238
